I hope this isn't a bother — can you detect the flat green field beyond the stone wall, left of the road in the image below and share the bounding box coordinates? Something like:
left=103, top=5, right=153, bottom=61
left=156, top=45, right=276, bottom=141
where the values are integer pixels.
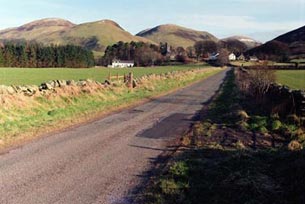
left=0, top=65, right=205, bottom=85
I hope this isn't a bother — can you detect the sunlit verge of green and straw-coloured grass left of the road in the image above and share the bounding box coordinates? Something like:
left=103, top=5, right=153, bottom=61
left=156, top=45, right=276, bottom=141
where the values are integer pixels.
left=0, top=68, right=222, bottom=147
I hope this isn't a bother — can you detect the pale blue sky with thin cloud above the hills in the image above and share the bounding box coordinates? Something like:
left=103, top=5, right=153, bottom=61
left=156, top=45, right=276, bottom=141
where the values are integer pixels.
left=0, top=0, right=305, bottom=42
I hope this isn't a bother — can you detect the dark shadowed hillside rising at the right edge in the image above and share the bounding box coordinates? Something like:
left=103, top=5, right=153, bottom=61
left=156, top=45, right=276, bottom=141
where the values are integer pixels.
left=249, top=26, right=305, bottom=61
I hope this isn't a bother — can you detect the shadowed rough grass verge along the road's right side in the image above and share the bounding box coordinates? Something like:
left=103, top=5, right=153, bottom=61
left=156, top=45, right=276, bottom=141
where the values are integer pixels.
left=139, top=69, right=305, bottom=204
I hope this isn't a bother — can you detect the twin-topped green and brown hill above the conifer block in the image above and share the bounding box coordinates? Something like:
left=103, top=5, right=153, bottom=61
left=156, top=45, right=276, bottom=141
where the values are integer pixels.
left=0, top=19, right=153, bottom=56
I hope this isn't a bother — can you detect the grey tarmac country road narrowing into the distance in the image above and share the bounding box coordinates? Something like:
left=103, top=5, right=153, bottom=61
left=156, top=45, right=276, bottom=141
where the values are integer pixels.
left=0, top=70, right=228, bottom=204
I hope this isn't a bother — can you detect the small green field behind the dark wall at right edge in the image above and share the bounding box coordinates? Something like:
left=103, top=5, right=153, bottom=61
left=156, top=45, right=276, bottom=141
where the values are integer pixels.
left=276, top=70, right=305, bottom=90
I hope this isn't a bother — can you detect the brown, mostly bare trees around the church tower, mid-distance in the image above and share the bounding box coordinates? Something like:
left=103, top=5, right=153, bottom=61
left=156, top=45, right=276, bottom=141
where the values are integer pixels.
left=98, top=40, right=247, bottom=66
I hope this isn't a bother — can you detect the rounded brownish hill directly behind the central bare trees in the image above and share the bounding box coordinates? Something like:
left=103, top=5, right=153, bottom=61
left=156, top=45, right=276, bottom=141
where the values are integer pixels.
left=137, top=24, right=218, bottom=48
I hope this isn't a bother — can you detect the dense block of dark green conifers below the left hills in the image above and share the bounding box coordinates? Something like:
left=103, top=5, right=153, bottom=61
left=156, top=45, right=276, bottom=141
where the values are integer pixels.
left=0, top=42, right=95, bottom=68
